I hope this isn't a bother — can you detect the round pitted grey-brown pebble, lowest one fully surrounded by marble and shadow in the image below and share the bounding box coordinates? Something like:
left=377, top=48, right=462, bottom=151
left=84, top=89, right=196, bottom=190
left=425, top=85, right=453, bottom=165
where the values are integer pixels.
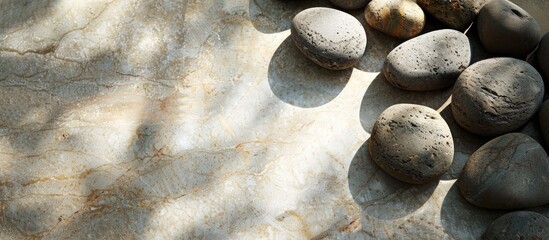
left=368, top=104, right=454, bottom=184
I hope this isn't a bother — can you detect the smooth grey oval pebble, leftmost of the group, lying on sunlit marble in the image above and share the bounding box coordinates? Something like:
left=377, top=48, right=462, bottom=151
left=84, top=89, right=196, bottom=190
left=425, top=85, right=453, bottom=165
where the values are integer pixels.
left=291, top=7, right=366, bottom=70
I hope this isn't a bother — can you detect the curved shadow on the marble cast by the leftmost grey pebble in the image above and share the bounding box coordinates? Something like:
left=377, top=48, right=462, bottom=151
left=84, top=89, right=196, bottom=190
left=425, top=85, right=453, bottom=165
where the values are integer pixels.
left=269, top=37, right=353, bottom=108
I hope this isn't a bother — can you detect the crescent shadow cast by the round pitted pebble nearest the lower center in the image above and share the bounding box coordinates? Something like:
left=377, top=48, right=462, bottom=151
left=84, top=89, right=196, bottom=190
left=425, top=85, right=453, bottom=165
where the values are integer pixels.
left=348, top=141, right=438, bottom=220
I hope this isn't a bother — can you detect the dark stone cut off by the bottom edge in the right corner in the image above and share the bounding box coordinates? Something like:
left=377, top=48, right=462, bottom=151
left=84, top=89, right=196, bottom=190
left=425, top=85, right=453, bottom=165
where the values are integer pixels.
left=482, top=211, right=549, bottom=240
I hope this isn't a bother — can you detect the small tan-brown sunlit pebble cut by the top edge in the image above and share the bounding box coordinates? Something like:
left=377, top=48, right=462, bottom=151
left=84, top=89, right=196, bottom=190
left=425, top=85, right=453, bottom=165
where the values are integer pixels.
left=364, top=0, right=425, bottom=39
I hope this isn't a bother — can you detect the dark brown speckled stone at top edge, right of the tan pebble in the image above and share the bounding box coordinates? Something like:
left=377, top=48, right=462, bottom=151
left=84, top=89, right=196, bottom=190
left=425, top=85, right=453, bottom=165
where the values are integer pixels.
left=417, top=0, right=487, bottom=31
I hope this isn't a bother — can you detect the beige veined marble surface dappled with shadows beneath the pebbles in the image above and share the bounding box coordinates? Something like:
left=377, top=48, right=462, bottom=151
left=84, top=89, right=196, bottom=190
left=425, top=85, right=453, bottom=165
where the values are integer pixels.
left=0, top=0, right=549, bottom=239
